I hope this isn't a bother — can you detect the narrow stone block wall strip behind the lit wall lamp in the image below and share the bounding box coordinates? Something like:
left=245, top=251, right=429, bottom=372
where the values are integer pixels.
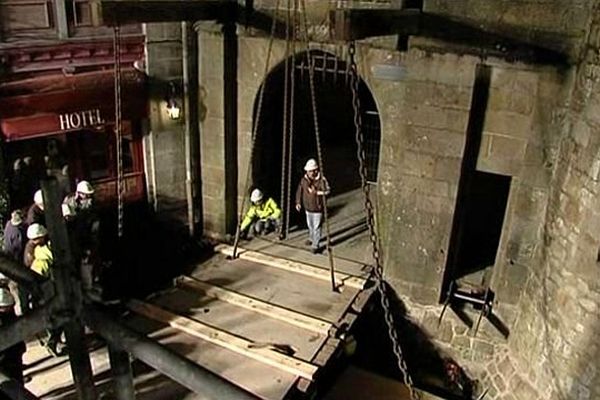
left=144, top=23, right=186, bottom=219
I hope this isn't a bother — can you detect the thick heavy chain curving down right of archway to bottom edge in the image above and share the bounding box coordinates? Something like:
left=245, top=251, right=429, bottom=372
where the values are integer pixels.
left=348, top=41, right=421, bottom=400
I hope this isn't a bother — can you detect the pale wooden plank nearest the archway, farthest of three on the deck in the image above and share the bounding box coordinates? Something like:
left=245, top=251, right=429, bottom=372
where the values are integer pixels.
left=215, top=244, right=367, bottom=290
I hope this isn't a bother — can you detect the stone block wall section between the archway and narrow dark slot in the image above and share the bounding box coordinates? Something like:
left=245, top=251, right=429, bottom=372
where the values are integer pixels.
left=360, top=46, right=476, bottom=304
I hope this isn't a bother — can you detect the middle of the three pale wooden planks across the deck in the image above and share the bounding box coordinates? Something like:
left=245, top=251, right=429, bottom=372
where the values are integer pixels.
left=176, top=276, right=332, bottom=335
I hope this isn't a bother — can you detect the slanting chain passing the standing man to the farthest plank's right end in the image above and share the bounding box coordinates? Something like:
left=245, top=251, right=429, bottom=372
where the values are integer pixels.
left=300, top=0, right=338, bottom=292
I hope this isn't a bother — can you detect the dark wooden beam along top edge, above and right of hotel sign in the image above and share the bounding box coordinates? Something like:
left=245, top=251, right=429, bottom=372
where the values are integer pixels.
left=92, top=0, right=238, bottom=25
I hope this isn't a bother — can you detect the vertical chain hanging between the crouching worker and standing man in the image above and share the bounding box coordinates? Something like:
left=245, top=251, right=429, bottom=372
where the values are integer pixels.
left=279, top=0, right=293, bottom=236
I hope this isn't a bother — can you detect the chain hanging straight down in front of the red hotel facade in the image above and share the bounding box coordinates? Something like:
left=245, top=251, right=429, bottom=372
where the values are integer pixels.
left=113, top=25, right=125, bottom=237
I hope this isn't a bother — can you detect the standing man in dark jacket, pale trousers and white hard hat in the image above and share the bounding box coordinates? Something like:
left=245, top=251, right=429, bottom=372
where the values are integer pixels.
left=296, top=158, right=330, bottom=253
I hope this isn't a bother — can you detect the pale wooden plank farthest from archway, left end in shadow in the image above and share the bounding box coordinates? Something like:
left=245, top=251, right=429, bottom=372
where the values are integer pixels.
left=127, top=300, right=318, bottom=380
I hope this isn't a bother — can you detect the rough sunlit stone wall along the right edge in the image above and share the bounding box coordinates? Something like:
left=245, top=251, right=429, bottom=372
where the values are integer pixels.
left=510, top=2, right=600, bottom=399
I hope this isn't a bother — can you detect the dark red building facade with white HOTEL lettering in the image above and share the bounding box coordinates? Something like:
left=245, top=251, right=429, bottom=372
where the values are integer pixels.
left=0, top=0, right=147, bottom=208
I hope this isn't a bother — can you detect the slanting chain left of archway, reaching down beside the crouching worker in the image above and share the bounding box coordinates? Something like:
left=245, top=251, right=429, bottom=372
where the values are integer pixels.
left=232, top=0, right=281, bottom=258
